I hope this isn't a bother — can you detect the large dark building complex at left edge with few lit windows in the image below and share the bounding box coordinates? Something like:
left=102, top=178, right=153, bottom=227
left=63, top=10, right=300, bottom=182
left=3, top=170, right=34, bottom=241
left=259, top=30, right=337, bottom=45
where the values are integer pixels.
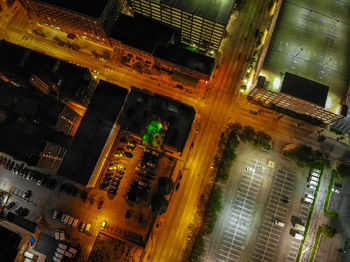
left=0, top=40, right=96, bottom=171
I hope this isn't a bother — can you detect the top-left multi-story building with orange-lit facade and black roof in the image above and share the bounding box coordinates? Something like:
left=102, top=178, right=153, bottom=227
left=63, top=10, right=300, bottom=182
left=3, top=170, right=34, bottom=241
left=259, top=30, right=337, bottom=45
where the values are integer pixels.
left=19, top=0, right=123, bottom=45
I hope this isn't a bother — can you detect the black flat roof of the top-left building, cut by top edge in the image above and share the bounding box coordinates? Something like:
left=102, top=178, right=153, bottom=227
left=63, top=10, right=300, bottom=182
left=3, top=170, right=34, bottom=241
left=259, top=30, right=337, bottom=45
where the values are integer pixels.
left=38, top=0, right=109, bottom=18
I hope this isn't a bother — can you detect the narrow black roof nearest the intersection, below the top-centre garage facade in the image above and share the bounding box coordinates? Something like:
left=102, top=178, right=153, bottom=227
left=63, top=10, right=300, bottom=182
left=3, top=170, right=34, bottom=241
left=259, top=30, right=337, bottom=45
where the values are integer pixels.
left=154, top=45, right=215, bottom=75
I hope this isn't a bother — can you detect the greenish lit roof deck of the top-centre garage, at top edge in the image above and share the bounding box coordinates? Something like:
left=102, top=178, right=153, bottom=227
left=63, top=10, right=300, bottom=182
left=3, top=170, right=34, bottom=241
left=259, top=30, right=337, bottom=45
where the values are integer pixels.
left=160, top=0, right=235, bottom=25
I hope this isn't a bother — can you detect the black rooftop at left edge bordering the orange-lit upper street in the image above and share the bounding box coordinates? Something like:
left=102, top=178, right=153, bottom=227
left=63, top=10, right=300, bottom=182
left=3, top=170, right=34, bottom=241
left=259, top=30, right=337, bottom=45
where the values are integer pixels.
left=0, top=40, right=91, bottom=102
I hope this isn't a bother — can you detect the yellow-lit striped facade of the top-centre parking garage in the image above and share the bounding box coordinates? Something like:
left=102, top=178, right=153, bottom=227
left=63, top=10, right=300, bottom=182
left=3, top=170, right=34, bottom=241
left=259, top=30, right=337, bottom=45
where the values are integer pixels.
left=130, top=0, right=234, bottom=52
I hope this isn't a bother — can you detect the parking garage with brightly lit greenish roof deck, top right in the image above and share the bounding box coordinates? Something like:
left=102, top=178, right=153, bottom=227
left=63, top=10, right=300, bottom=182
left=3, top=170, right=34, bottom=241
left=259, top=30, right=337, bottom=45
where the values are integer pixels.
left=250, top=0, right=350, bottom=123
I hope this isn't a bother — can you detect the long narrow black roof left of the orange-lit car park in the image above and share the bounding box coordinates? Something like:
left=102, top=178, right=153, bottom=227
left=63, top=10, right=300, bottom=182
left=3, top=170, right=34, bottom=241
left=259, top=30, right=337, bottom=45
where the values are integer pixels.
left=58, top=80, right=127, bottom=186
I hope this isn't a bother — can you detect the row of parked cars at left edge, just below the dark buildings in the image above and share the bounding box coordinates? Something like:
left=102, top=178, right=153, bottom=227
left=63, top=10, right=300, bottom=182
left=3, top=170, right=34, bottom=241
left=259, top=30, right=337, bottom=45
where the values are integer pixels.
left=0, top=155, right=53, bottom=190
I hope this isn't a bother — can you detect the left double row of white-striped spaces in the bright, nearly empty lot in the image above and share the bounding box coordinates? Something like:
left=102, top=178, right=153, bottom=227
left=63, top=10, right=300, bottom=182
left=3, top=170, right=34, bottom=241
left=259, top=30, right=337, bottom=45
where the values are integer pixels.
left=216, top=159, right=263, bottom=261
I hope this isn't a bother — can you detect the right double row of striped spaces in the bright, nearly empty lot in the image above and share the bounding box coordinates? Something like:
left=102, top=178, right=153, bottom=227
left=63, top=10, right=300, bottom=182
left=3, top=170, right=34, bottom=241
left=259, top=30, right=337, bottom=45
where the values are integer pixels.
left=252, top=169, right=296, bottom=261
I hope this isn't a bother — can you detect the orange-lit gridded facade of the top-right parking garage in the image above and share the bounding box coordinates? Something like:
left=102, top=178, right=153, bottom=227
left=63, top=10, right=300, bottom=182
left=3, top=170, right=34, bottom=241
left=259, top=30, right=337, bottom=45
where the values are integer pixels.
left=249, top=86, right=343, bottom=123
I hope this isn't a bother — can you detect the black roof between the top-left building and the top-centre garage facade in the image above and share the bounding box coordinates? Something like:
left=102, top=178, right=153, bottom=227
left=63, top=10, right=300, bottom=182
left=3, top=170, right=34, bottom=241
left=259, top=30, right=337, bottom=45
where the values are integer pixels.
left=110, top=14, right=175, bottom=54
